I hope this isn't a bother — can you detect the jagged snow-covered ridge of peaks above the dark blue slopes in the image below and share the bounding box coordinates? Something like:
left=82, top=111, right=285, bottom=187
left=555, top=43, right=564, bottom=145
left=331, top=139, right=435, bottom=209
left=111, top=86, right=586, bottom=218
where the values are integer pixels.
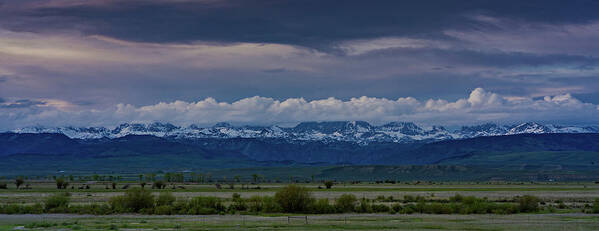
left=12, top=121, right=599, bottom=144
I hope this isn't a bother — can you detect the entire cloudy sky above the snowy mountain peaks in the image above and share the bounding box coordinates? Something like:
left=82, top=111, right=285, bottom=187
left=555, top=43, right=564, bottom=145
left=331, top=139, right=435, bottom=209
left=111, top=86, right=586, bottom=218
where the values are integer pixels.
left=0, top=0, right=599, bottom=131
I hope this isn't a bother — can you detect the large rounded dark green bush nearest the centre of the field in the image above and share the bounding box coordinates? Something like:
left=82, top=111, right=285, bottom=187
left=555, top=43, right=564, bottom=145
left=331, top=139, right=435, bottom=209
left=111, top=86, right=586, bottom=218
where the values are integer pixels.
left=275, top=185, right=314, bottom=213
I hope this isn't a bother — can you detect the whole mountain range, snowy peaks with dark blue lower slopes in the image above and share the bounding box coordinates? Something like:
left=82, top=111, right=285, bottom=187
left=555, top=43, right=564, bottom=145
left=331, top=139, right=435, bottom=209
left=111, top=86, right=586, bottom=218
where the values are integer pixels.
left=0, top=121, right=599, bottom=179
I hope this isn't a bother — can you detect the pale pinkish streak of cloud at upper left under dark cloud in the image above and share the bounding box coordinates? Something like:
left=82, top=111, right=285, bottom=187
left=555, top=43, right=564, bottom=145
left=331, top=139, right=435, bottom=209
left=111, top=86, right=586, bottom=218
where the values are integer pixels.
left=0, top=29, right=327, bottom=72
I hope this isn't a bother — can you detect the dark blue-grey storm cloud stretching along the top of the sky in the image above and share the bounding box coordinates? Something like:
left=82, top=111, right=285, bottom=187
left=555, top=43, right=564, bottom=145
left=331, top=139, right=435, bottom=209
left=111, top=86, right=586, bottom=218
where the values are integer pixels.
left=0, top=0, right=599, bottom=48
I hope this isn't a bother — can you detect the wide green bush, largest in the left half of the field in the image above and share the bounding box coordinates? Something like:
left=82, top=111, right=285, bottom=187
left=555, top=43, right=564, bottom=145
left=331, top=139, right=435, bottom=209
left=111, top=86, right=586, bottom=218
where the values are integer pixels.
left=109, top=188, right=154, bottom=212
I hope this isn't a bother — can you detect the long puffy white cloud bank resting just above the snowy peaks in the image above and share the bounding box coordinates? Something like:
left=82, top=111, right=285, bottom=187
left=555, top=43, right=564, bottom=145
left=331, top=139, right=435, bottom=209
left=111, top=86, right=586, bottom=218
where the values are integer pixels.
left=0, top=88, right=599, bottom=130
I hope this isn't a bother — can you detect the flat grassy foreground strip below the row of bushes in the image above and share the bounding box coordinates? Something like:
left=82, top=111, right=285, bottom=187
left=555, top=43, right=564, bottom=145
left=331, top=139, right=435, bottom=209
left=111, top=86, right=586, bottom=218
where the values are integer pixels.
left=0, top=213, right=599, bottom=231
